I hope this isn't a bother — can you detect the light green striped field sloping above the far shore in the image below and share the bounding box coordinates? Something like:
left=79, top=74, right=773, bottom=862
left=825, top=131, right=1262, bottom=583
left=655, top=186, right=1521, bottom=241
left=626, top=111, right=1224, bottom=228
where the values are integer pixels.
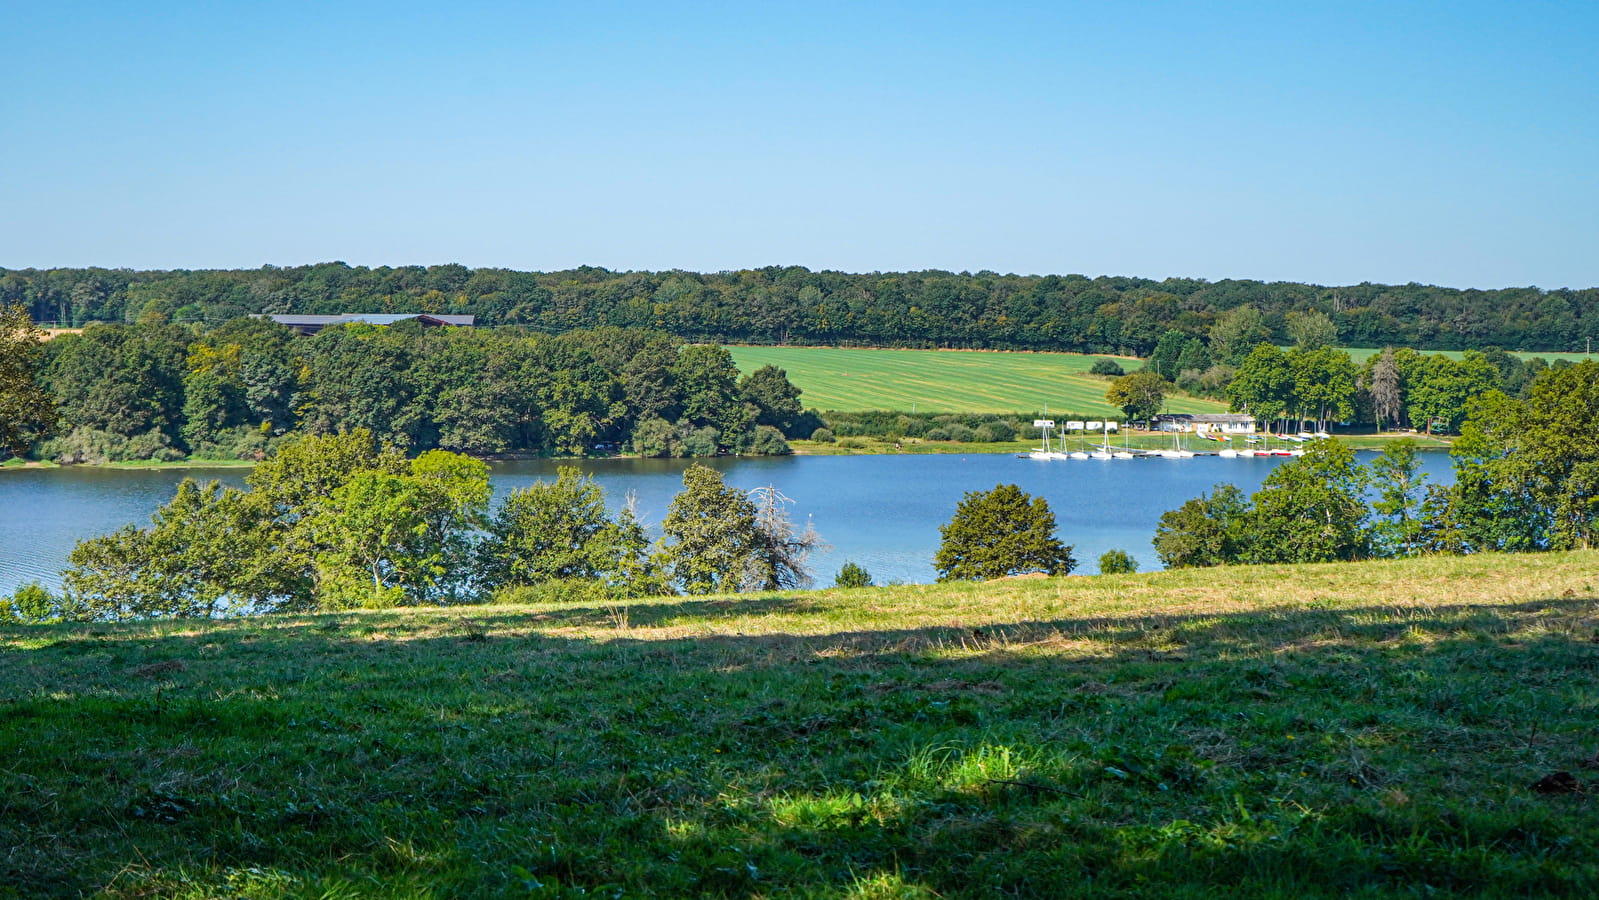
left=728, top=347, right=1226, bottom=416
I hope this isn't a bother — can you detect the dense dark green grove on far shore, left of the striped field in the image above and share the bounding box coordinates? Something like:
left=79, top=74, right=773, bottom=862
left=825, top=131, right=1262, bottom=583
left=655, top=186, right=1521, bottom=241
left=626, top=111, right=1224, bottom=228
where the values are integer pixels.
left=21, top=307, right=822, bottom=462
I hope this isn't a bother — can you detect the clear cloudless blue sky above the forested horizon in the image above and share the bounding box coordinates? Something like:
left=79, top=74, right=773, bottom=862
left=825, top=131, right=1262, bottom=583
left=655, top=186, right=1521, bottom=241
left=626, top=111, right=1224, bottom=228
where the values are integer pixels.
left=0, top=0, right=1599, bottom=288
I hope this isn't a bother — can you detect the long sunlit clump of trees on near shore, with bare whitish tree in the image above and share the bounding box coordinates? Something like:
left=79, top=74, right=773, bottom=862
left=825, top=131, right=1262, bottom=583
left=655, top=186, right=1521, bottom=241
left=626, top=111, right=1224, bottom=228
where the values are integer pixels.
left=12, top=428, right=819, bottom=620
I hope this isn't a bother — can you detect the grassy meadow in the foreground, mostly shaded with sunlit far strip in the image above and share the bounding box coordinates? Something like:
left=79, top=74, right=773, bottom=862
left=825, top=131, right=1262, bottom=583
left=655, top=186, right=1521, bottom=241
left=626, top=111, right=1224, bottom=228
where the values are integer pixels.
left=0, top=553, right=1599, bottom=898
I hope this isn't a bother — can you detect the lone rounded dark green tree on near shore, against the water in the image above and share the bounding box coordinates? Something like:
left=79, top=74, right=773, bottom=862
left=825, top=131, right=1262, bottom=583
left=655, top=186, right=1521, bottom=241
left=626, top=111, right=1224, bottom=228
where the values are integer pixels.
left=932, top=484, right=1076, bottom=582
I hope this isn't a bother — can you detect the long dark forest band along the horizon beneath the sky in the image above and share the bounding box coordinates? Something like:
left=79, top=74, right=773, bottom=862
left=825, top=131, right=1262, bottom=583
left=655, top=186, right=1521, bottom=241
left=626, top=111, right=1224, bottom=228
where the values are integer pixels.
left=0, top=262, right=1599, bottom=356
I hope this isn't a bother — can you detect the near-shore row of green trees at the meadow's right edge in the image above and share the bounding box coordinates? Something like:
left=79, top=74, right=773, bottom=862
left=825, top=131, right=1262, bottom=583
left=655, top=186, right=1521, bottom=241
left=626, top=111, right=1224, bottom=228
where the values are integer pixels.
left=1154, top=361, right=1599, bottom=567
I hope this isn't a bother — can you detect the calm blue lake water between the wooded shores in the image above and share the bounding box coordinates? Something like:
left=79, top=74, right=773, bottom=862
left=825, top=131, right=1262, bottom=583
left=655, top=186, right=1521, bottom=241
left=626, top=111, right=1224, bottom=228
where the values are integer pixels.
left=0, top=452, right=1452, bottom=593
